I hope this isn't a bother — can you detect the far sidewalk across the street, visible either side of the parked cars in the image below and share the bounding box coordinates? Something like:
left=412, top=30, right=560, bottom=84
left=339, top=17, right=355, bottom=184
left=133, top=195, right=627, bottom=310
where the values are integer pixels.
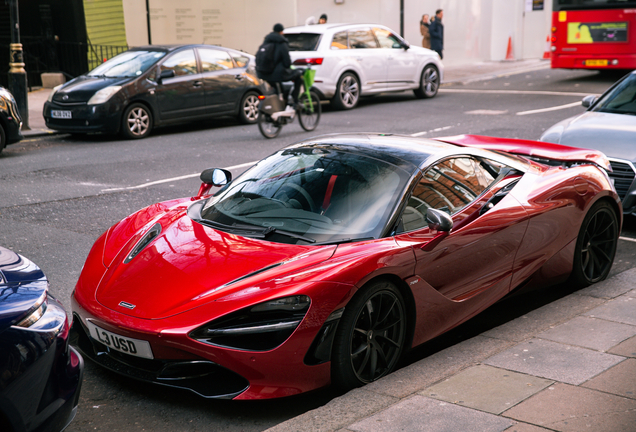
left=22, top=59, right=550, bottom=138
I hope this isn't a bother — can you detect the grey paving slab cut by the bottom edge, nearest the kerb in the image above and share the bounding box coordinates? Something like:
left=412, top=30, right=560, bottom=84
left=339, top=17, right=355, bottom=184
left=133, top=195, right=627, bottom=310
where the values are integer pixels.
left=347, top=395, right=513, bottom=432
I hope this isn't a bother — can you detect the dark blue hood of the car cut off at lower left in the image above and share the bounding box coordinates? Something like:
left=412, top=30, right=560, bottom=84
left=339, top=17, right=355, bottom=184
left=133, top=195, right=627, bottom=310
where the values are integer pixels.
left=0, top=247, right=48, bottom=332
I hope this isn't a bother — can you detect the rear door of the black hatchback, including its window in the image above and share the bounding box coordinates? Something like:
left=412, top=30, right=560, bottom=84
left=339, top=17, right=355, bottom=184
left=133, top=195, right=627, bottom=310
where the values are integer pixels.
left=198, top=48, right=247, bottom=114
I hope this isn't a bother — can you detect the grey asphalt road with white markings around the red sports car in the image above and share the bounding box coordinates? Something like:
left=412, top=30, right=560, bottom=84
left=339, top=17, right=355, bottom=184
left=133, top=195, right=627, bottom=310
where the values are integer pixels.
left=0, top=69, right=636, bottom=432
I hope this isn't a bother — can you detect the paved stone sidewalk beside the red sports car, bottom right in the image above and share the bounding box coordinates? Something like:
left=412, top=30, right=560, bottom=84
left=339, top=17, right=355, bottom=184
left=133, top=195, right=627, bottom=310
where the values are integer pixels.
left=267, top=269, right=636, bottom=432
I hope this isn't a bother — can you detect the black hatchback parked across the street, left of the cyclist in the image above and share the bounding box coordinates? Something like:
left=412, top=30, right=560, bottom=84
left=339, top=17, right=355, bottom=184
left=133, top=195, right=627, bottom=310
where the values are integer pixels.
left=43, top=45, right=264, bottom=138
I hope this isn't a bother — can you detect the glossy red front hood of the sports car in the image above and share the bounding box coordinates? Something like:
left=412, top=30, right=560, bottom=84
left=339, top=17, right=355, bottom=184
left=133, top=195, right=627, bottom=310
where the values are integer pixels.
left=95, top=212, right=336, bottom=319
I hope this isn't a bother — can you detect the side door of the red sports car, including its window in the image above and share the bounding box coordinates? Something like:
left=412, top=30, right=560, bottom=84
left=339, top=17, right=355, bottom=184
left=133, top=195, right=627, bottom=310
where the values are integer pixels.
left=397, top=156, right=528, bottom=302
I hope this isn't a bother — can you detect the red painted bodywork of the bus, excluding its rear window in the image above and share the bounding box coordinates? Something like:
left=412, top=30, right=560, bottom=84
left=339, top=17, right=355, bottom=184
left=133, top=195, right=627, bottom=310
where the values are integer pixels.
left=550, top=8, right=636, bottom=69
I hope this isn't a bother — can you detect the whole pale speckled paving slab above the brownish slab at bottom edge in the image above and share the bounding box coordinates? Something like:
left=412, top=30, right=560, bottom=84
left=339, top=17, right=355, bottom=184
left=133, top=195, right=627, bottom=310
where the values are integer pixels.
left=484, top=339, right=625, bottom=385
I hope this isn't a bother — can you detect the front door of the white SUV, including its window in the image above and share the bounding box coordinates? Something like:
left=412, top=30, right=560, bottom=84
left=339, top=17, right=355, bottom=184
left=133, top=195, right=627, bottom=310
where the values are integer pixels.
left=373, top=27, right=419, bottom=90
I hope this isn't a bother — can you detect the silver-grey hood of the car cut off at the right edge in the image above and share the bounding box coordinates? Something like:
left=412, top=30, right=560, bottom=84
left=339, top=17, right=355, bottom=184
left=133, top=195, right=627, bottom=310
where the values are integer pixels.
left=542, top=111, right=636, bottom=161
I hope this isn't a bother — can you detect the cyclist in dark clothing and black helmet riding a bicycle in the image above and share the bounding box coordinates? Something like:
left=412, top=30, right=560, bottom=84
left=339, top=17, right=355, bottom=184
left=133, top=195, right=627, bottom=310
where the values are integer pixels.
left=256, top=24, right=303, bottom=107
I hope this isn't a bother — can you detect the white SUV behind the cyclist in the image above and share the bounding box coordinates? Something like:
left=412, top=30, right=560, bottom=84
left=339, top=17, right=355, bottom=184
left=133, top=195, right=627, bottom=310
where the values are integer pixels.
left=284, top=24, right=444, bottom=109
